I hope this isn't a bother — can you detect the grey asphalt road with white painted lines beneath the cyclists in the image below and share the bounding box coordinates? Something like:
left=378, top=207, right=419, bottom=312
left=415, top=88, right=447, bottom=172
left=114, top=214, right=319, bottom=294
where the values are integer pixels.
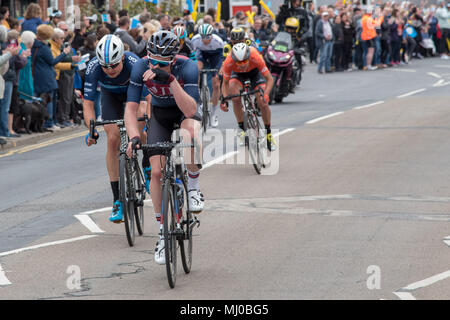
left=0, top=58, right=450, bottom=300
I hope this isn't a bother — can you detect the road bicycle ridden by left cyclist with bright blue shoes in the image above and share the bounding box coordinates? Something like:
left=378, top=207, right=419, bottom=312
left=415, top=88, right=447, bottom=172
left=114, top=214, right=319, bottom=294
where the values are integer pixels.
left=89, top=115, right=148, bottom=247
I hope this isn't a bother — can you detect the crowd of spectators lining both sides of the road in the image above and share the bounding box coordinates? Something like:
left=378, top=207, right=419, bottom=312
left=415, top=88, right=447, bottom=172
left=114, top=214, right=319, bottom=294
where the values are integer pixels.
left=0, top=0, right=450, bottom=146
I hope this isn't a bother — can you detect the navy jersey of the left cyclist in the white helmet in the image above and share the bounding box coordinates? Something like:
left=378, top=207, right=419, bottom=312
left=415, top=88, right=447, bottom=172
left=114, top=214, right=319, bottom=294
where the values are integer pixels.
left=84, top=51, right=139, bottom=101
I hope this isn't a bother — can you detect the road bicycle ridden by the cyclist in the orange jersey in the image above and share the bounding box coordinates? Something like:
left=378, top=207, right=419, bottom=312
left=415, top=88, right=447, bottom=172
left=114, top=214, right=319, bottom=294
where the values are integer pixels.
left=222, top=80, right=267, bottom=174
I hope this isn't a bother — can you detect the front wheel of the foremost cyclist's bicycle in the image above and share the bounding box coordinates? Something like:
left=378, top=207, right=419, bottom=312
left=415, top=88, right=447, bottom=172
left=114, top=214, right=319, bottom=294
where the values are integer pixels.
left=161, top=180, right=177, bottom=288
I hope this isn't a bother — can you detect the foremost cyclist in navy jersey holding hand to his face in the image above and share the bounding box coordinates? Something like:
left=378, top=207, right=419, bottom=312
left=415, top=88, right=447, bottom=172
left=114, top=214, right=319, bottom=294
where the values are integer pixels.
left=125, top=30, right=204, bottom=264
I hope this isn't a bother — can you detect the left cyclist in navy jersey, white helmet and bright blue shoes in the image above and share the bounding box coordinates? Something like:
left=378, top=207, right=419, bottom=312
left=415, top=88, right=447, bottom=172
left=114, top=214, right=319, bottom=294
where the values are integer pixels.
left=83, top=35, right=145, bottom=223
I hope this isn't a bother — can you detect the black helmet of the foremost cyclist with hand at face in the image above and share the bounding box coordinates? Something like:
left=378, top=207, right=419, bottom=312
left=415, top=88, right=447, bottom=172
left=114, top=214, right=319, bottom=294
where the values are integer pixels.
left=147, top=30, right=179, bottom=58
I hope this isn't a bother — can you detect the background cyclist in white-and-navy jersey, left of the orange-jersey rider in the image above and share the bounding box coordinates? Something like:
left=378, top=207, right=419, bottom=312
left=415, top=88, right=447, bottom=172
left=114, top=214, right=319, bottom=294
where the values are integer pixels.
left=192, top=23, right=225, bottom=127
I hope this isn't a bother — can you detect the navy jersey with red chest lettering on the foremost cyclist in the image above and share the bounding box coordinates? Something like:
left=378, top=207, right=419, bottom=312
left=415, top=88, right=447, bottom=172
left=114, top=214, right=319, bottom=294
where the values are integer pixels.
left=127, top=55, right=200, bottom=107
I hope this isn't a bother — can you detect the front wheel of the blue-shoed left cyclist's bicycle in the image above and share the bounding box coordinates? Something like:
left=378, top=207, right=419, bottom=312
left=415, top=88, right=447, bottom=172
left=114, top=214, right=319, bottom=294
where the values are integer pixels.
left=119, top=154, right=135, bottom=247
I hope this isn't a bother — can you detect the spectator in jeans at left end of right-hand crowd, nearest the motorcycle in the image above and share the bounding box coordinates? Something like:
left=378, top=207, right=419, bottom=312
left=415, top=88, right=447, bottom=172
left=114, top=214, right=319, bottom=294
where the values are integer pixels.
left=315, top=11, right=333, bottom=73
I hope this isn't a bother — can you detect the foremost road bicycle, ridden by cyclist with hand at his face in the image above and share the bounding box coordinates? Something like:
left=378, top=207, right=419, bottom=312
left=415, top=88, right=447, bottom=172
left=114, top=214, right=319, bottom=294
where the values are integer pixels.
left=140, top=141, right=200, bottom=288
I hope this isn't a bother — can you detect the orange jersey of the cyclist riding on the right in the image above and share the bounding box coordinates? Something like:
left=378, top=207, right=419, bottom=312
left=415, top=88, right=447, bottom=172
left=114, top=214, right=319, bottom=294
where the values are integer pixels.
left=223, top=47, right=270, bottom=80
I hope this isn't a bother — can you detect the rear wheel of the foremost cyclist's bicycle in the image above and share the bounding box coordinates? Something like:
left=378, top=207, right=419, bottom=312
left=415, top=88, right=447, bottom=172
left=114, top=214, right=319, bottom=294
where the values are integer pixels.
left=178, top=176, right=194, bottom=273
